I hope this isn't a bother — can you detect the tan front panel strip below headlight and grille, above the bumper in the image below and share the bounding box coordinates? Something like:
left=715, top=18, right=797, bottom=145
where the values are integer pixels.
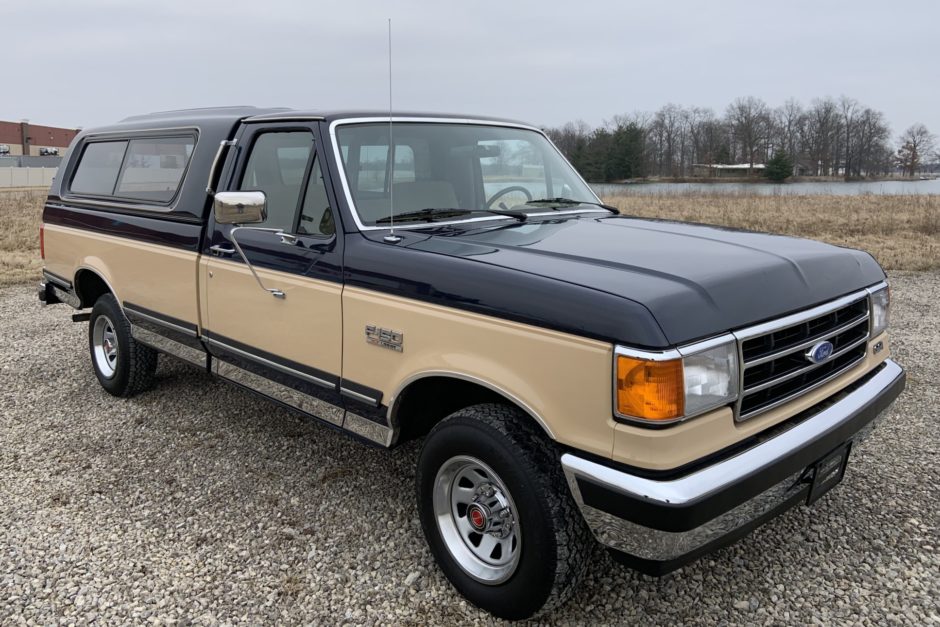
left=613, top=334, right=891, bottom=470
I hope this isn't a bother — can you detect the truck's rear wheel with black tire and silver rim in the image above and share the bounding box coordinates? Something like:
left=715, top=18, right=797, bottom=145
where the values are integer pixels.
left=88, top=294, right=157, bottom=396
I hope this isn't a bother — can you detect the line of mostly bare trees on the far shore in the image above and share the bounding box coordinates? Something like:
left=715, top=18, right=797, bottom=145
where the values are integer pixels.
left=546, top=96, right=940, bottom=182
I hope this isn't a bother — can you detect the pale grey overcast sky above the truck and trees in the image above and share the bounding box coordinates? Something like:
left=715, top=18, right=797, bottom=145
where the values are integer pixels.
left=0, top=0, right=940, bottom=136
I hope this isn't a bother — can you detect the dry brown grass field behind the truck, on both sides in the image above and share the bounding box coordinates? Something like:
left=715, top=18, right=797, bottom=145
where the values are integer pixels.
left=0, top=191, right=940, bottom=286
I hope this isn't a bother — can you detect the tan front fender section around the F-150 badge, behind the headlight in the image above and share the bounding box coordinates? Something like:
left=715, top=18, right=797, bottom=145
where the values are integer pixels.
left=343, top=287, right=613, bottom=457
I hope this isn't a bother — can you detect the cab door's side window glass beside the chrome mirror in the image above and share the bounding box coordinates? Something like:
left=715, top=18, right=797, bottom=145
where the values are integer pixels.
left=238, top=131, right=313, bottom=232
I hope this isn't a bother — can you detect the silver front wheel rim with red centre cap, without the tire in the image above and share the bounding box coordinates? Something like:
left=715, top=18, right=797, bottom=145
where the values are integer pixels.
left=433, top=455, right=522, bottom=585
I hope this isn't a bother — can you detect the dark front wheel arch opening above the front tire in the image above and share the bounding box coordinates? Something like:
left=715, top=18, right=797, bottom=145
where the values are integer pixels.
left=388, top=370, right=556, bottom=444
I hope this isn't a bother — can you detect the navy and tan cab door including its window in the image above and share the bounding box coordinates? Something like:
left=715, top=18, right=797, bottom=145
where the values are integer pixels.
left=200, top=124, right=343, bottom=425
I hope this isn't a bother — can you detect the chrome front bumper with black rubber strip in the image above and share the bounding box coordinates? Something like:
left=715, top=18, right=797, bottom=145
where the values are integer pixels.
left=561, top=360, right=905, bottom=575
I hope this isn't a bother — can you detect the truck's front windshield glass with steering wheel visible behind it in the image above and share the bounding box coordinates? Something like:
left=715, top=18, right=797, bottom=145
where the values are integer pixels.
left=336, top=122, right=597, bottom=226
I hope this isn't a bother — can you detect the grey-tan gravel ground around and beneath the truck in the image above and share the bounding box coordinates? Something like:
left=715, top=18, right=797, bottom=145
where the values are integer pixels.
left=0, top=273, right=940, bottom=625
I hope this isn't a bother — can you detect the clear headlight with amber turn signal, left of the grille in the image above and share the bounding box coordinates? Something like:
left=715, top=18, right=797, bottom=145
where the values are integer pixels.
left=615, top=336, right=738, bottom=424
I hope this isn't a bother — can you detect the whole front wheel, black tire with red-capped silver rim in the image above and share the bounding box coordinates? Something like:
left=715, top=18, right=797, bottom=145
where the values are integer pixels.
left=416, top=404, right=592, bottom=619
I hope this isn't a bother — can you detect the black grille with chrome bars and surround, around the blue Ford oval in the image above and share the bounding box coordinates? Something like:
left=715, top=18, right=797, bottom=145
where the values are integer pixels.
left=735, top=292, right=869, bottom=421
